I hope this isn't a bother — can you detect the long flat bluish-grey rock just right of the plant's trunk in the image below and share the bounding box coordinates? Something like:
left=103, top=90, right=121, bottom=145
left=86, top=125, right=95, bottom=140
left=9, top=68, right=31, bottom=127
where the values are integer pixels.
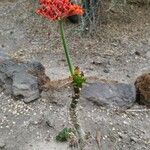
left=81, top=81, right=135, bottom=108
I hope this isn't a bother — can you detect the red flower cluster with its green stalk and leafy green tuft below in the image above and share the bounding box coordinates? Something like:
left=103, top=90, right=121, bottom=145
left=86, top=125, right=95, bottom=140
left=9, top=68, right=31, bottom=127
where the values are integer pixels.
left=36, top=0, right=86, bottom=88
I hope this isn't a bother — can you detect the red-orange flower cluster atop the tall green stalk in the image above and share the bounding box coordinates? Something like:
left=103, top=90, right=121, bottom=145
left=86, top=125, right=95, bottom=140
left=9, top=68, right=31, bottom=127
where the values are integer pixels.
left=36, top=0, right=83, bottom=20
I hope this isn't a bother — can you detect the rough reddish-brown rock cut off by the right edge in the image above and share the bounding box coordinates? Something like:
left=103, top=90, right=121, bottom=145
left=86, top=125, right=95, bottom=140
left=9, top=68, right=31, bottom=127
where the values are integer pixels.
left=135, top=73, right=150, bottom=106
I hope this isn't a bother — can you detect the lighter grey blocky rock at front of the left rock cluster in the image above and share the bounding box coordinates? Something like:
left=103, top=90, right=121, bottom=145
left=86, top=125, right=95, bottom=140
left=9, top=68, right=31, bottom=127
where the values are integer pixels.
left=12, top=73, right=40, bottom=103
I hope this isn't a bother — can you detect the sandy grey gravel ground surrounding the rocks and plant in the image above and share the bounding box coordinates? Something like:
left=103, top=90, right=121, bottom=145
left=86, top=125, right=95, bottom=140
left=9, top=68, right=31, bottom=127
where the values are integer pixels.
left=0, top=0, right=150, bottom=150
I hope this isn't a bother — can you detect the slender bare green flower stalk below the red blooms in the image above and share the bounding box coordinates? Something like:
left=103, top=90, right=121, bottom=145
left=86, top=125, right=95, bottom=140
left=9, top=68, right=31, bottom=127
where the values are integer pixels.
left=59, top=20, right=74, bottom=76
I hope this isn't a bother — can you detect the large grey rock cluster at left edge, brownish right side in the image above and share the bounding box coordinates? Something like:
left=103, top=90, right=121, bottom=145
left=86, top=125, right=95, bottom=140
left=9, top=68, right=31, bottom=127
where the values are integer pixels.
left=0, top=51, right=49, bottom=103
